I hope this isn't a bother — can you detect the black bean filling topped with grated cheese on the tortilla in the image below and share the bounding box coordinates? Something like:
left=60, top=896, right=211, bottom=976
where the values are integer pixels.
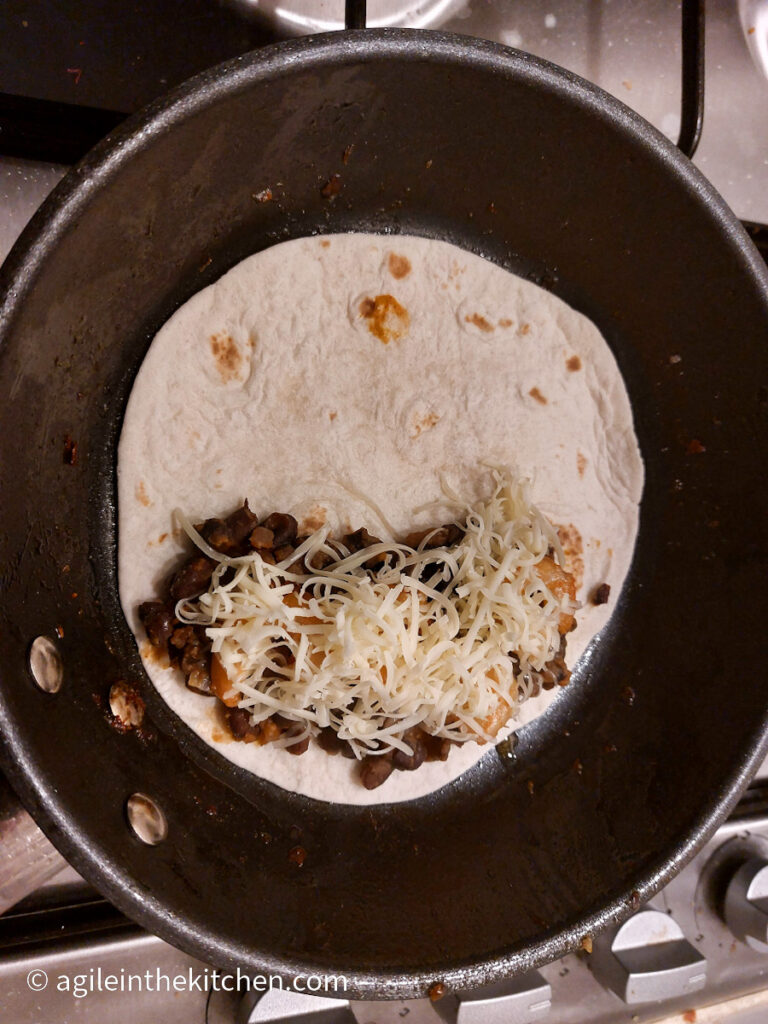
left=139, top=472, right=575, bottom=788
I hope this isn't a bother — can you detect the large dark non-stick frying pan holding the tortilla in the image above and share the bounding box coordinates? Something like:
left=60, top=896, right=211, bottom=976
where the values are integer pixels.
left=0, top=14, right=768, bottom=997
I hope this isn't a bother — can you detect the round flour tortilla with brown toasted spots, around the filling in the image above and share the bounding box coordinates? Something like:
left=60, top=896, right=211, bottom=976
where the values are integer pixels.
left=118, top=233, right=643, bottom=804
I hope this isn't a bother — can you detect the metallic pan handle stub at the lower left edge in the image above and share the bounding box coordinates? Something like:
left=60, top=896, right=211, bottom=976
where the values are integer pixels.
left=0, top=775, right=67, bottom=913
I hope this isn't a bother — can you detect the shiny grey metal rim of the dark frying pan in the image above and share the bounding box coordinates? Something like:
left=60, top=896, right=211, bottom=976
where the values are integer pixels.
left=0, top=29, right=768, bottom=998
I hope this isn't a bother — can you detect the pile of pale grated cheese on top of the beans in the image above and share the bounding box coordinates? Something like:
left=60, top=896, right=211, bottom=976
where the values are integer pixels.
left=176, top=470, right=572, bottom=758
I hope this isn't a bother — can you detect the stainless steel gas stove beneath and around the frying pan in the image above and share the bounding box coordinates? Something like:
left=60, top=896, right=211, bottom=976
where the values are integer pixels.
left=0, top=0, right=768, bottom=1024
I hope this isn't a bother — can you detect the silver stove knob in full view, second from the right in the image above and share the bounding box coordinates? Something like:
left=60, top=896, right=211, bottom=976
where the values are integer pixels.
left=590, top=909, right=707, bottom=1006
